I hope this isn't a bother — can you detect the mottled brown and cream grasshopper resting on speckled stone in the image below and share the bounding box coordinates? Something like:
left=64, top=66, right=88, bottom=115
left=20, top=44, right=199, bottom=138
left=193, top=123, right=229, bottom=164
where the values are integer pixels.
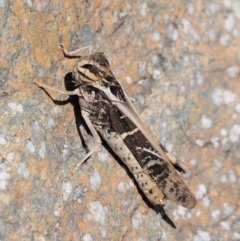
left=36, top=47, right=196, bottom=209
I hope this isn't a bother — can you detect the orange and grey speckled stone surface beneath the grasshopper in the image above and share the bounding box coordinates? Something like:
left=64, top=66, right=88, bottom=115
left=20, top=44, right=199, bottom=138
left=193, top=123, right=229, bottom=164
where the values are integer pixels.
left=0, top=0, right=240, bottom=241
